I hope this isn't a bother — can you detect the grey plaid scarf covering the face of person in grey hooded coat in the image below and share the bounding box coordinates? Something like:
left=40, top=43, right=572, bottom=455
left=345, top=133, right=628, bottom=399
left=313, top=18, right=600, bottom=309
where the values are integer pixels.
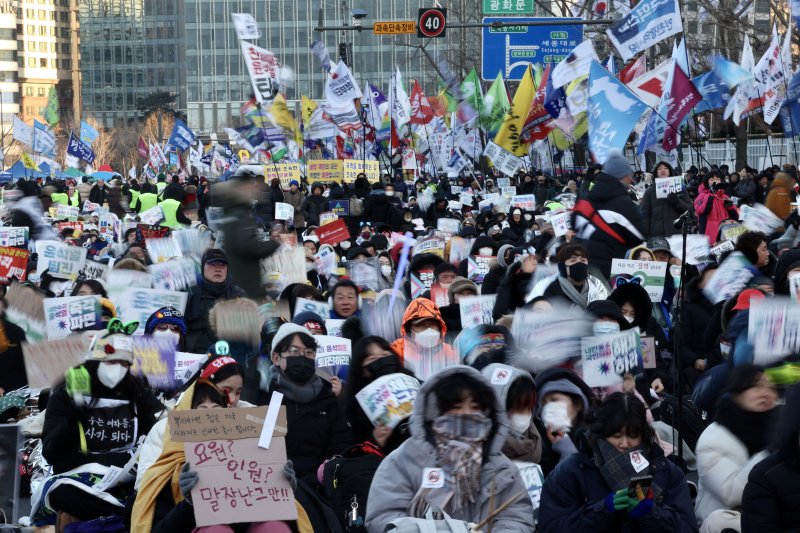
left=410, top=414, right=492, bottom=518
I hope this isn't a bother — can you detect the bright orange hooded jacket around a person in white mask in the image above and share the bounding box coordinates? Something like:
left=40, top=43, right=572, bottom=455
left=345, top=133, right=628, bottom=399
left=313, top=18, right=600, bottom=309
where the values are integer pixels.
left=391, top=298, right=460, bottom=379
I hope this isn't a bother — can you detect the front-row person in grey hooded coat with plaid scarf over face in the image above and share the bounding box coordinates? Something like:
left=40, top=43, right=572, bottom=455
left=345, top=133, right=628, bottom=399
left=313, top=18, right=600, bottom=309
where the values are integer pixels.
left=366, top=365, right=533, bottom=533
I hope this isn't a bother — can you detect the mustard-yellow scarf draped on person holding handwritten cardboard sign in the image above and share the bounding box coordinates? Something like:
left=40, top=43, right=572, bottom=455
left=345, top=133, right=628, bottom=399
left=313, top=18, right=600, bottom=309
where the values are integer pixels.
left=131, top=385, right=194, bottom=532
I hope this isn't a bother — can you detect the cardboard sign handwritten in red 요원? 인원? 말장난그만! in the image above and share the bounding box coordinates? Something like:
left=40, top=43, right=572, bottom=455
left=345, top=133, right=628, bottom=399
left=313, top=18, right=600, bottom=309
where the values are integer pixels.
left=168, top=407, right=297, bottom=527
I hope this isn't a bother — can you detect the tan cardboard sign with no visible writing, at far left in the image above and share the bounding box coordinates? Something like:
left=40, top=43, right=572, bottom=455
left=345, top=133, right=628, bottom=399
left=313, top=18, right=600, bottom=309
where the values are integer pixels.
left=22, top=335, right=91, bottom=389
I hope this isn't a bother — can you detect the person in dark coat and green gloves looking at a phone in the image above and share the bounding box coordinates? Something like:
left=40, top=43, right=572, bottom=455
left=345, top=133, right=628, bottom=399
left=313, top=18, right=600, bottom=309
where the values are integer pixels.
left=537, top=392, right=698, bottom=533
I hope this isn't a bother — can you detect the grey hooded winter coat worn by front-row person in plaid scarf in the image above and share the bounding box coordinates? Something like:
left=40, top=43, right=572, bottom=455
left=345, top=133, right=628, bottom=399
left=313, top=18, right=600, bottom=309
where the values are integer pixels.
left=365, top=366, right=533, bottom=533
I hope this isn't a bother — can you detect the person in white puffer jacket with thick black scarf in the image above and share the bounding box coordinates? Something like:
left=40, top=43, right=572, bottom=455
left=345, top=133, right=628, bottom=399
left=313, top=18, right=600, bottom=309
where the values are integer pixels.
left=695, top=365, right=778, bottom=533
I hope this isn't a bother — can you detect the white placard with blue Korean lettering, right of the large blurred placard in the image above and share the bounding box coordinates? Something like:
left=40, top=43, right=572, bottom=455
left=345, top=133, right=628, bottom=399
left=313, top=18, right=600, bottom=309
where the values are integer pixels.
left=581, top=329, right=643, bottom=387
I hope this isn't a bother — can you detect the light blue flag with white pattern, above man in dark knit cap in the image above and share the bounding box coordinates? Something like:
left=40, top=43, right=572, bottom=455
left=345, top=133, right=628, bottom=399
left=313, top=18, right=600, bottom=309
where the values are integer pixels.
left=587, top=61, right=648, bottom=164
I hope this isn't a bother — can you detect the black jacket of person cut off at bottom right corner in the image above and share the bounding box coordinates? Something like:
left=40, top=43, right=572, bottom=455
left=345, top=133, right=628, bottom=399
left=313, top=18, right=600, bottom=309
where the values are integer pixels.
left=742, top=385, right=800, bottom=533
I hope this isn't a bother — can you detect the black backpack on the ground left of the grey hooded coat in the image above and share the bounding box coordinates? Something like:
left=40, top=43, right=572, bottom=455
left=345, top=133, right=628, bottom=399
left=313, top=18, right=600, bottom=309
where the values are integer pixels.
left=322, top=442, right=385, bottom=532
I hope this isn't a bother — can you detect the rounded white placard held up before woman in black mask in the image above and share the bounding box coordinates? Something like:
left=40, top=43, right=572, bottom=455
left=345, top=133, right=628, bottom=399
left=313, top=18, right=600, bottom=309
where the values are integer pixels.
left=356, top=374, right=420, bottom=429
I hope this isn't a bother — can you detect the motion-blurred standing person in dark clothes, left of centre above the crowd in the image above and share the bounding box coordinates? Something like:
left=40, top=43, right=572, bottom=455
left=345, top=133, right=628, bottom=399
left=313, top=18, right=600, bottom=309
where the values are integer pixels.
left=213, top=170, right=280, bottom=300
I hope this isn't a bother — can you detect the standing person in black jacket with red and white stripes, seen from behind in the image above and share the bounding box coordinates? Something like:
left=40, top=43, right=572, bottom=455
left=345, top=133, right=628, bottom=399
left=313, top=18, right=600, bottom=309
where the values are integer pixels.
left=573, top=151, right=645, bottom=279
